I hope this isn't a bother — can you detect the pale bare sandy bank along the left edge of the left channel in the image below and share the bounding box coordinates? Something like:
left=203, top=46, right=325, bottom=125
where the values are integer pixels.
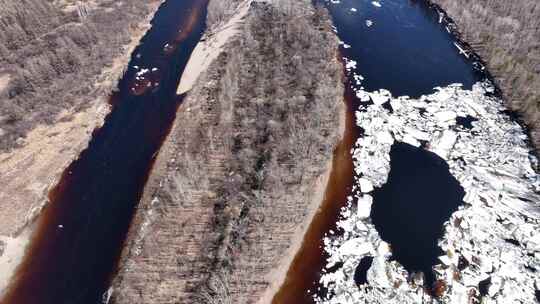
left=0, top=1, right=161, bottom=294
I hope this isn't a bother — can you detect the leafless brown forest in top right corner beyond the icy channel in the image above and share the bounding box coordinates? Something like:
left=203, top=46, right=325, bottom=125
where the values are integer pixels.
left=431, top=0, right=540, bottom=149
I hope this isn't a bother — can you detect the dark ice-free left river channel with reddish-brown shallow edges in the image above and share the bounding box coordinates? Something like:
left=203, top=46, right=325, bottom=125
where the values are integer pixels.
left=0, top=0, right=207, bottom=304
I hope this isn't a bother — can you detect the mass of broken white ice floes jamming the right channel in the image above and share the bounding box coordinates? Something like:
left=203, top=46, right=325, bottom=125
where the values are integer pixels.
left=316, top=74, right=540, bottom=304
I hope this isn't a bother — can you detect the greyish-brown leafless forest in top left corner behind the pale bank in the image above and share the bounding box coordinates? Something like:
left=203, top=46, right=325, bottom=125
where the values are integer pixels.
left=0, top=0, right=157, bottom=151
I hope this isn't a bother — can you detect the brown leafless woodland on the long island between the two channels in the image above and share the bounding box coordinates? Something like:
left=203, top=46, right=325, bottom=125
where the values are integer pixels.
left=113, top=0, right=344, bottom=304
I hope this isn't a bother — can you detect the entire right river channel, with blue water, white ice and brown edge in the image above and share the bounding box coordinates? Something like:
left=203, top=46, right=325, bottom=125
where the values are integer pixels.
left=274, top=0, right=540, bottom=304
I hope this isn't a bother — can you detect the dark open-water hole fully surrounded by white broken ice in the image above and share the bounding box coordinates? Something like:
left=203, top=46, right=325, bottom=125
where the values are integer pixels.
left=371, top=142, right=465, bottom=284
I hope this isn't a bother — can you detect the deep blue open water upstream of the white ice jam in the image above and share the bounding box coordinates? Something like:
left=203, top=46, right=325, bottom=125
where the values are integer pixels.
left=315, top=0, right=486, bottom=97
